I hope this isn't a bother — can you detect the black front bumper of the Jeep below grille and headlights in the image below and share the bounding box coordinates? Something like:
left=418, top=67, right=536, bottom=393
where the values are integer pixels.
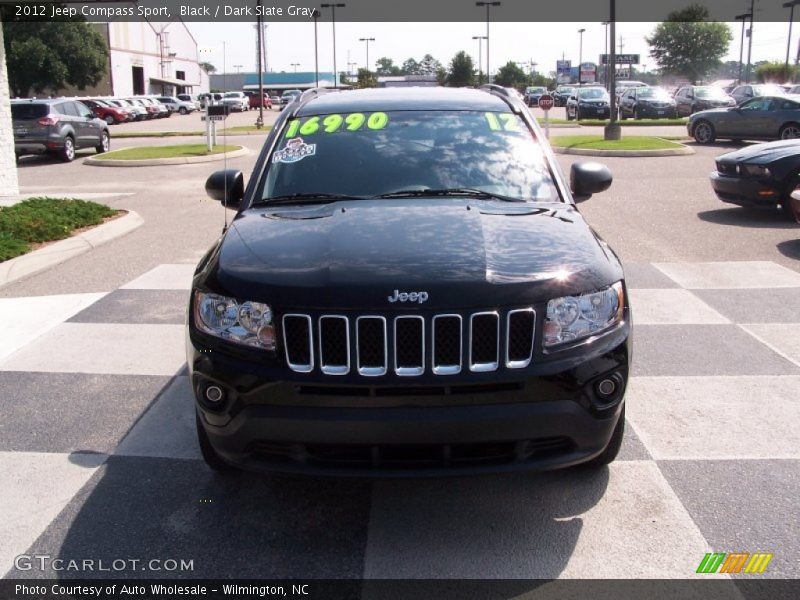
left=187, top=320, right=631, bottom=477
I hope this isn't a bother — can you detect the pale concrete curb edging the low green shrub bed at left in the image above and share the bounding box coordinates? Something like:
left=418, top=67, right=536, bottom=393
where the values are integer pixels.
left=0, top=210, right=144, bottom=287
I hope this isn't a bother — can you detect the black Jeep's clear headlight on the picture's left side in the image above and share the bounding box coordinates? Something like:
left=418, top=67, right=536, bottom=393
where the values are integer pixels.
left=194, top=291, right=275, bottom=350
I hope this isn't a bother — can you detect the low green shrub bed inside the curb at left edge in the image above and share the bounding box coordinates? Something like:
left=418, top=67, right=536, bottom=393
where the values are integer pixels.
left=0, top=197, right=116, bottom=262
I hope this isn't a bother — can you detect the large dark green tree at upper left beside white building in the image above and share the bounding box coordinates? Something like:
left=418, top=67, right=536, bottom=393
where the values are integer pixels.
left=0, top=11, right=108, bottom=97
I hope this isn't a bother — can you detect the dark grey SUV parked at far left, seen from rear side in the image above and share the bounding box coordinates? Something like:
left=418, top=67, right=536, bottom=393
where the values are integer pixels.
left=11, top=99, right=111, bottom=162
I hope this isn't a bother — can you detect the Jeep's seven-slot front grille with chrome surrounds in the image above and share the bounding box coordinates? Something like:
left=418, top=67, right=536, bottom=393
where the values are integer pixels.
left=282, top=308, right=536, bottom=377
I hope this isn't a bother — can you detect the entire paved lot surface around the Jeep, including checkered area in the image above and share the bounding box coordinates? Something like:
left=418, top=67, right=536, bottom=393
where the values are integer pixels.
left=0, top=109, right=800, bottom=584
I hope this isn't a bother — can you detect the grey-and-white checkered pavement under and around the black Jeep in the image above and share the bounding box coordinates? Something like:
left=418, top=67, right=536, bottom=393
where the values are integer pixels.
left=0, top=262, right=800, bottom=585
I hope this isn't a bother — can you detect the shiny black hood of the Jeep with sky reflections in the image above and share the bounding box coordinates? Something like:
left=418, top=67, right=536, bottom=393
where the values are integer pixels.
left=198, top=199, right=622, bottom=309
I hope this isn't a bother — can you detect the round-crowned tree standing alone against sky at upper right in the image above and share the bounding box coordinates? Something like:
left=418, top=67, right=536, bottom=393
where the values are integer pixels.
left=645, top=4, right=733, bottom=83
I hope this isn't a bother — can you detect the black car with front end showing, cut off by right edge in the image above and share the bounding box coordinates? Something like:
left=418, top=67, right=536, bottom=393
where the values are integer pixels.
left=711, top=140, right=800, bottom=218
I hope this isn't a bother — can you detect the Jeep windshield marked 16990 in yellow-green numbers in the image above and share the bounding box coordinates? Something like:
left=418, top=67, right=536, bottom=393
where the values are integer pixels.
left=261, top=111, right=560, bottom=202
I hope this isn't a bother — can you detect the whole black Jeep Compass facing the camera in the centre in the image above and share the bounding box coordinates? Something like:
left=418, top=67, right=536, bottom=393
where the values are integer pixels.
left=187, top=87, right=631, bottom=476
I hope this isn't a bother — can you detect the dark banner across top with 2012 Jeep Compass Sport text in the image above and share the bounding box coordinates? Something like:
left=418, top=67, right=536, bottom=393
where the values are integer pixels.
left=0, top=0, right=789, bottom=23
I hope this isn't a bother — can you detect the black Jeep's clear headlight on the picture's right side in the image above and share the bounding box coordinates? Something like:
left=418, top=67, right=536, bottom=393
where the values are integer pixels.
left=543, top=281, right=625, bottom=348
